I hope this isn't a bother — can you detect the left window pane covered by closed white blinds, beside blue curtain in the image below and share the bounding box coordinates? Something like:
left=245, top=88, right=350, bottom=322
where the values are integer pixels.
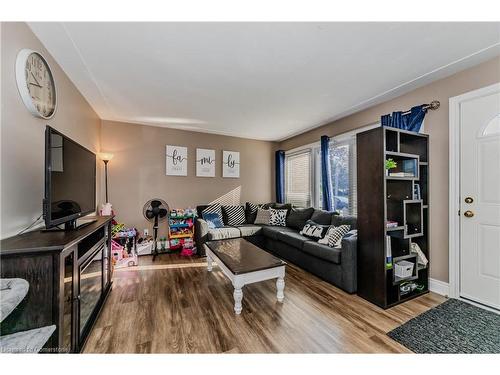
left=285, top=149, right=312, bottom=207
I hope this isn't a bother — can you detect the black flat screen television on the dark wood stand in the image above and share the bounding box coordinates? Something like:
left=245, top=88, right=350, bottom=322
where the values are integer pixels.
left=43, top=126, right=96, bottom=230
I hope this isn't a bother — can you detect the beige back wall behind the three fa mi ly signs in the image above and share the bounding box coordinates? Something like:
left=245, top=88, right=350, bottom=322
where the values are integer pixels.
left=101, top=121, right=276, bottom=235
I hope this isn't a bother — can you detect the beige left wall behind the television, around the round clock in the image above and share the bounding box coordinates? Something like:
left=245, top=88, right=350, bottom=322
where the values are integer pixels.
left=0, top=22, right=102, bottom=238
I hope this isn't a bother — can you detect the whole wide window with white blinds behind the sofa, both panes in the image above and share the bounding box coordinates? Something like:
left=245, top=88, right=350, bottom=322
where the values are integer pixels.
left=285, top=124, right=380, bottom=215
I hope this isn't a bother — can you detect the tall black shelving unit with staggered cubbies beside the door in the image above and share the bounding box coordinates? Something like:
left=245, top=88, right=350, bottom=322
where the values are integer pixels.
left=357, top=127, right=430, bottom=308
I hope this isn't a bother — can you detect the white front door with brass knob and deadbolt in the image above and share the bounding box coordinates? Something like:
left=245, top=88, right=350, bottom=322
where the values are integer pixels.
left=459, top=89, right=500, bottom=309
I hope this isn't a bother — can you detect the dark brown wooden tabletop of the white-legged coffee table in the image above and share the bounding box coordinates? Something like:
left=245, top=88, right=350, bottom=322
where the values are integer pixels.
left=206, top=238, right=286, bottom=275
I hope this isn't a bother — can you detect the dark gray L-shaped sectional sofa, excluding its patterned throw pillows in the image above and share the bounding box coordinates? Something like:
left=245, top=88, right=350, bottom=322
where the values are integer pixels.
left=195, top=206, right=357, bottom=293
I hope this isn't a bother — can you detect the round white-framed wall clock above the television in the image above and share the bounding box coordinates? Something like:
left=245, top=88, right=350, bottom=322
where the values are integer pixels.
left=16, top=49, right=57, bottom=119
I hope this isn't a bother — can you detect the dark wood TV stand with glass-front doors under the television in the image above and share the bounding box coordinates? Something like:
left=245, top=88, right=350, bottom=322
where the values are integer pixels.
left=0, top=216, right=112, bottom=353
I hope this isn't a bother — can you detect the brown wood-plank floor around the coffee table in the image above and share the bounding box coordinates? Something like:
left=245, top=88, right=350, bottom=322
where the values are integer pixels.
left=84, top=255, right=445, bottom=353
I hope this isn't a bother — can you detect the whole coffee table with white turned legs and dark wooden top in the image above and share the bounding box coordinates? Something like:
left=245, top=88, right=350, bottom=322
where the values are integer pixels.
left=206, top=238, right=286, bottom=314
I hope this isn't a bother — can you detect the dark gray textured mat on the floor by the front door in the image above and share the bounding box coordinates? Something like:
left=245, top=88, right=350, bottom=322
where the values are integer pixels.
left=387, top=299, right=500, bottom=353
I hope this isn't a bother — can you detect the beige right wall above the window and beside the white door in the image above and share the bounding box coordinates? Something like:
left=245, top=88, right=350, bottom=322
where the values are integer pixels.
left=279, top=57, right=500, bottom=282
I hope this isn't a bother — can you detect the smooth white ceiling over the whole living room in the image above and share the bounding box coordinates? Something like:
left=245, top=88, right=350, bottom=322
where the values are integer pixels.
left=29, top=22, right=500, bottom=140
